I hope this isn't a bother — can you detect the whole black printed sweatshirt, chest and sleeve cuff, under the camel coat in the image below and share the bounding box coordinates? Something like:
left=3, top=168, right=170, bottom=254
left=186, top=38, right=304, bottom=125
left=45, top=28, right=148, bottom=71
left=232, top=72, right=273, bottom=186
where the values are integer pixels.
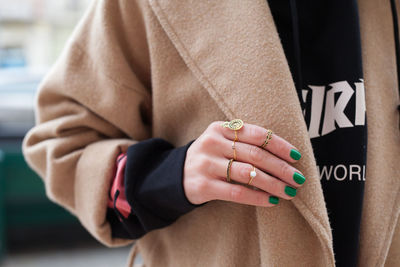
left=107, top=0, right=399, bottom=266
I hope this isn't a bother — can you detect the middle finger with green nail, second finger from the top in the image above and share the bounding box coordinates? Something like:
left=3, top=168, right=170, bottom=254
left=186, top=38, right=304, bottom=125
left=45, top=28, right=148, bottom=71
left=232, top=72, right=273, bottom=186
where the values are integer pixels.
left=220, top=140, right=305, bottom=187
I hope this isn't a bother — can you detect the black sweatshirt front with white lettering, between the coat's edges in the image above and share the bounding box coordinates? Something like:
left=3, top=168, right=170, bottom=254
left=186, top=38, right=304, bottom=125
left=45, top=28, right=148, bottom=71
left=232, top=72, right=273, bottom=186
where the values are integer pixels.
left=268, top=0, right=367, bottom=266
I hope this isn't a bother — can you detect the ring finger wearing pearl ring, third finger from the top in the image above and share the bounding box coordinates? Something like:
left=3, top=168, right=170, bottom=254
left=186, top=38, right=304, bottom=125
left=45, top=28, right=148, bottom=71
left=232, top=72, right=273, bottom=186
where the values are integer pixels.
left=216, top=160, right=299, bottom=200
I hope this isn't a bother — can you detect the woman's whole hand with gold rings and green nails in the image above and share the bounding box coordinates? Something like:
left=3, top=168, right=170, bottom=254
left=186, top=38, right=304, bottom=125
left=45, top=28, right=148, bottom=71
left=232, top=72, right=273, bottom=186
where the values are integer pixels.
left=183, top=121, right=305, bottom=207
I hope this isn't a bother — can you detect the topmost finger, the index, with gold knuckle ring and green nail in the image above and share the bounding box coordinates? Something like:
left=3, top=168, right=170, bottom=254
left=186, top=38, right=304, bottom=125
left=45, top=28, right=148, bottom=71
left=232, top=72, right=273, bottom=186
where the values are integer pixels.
left=217, top=122, right=301, bottom=163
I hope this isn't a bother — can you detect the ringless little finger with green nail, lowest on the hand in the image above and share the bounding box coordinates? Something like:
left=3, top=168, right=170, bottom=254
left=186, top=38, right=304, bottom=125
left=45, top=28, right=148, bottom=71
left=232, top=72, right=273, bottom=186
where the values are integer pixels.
left=209, top=179, right=279, bottom=207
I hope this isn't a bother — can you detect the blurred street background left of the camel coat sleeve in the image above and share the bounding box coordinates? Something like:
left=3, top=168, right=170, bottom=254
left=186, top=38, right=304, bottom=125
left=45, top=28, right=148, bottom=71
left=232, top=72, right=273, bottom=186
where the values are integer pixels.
left=0, top=0, right=134, bottom=267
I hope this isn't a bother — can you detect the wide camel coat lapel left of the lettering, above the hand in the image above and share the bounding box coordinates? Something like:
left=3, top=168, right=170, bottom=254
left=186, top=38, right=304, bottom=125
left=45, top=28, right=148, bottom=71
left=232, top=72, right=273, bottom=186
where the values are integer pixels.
left=149, top=0, right=333, bottom=262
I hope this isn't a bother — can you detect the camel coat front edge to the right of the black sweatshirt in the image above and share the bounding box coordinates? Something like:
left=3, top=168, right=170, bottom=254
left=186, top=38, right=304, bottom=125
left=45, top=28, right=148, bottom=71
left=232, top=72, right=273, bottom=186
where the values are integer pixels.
left=358, top=0, right=400, bottom=266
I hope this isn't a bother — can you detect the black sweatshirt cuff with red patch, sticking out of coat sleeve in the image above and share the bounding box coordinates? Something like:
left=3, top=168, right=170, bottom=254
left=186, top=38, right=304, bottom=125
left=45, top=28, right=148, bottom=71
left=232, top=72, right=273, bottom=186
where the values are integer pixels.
left=108, top=138, right=206, bottom=239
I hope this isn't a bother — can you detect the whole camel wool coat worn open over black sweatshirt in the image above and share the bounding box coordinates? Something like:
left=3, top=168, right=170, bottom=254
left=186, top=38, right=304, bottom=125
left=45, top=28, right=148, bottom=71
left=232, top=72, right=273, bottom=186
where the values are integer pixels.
left=23, top=0, right=400, bottom=267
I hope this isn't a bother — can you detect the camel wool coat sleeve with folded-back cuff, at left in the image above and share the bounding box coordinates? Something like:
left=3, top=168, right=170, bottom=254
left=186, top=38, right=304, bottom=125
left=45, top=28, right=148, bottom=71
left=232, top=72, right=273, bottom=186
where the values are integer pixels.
left=23, top=0, right=151, bottom=246
